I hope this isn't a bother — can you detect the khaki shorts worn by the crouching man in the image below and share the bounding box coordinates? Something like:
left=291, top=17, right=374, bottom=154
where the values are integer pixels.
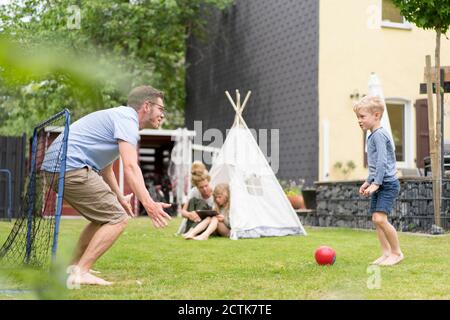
left=47, top=167, right=128, bottom=224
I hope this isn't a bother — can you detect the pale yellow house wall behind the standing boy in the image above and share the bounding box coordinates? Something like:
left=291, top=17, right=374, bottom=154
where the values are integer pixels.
left=319, top=0, right=450, bottom=181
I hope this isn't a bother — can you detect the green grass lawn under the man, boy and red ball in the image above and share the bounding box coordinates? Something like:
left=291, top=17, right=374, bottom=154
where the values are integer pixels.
left=0, top=218, right=450, bottom=300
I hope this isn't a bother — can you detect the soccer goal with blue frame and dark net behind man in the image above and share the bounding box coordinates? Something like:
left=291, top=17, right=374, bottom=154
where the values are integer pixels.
left=0, top=109, right=70, bottom=268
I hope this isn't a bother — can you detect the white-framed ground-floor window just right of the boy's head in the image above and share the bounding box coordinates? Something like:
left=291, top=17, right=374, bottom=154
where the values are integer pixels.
left=386, top=98, right=413, bottom=168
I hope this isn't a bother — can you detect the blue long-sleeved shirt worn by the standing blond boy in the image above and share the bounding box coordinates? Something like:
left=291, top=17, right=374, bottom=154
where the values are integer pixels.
left=367, top=127, right=397, bottom=185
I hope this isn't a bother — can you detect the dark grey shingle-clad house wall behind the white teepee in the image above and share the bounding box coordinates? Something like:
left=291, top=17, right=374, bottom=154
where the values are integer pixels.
left=185, top=0, right=319, bottom=184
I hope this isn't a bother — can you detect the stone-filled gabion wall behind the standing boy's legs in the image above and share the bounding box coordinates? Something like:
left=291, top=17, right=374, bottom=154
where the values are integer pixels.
left=302, top=177, right=450, bottom=233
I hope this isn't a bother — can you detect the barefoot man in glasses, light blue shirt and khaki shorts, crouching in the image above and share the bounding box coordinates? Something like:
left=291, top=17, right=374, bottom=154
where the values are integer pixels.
left=43, top=86, right=170, bottom=285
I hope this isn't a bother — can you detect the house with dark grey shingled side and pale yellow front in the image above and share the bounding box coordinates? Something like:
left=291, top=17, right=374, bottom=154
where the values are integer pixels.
left=186, top=0, right=450, bottom=184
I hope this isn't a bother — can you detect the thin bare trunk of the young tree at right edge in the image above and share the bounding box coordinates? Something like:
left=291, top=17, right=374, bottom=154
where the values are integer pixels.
left=434, top=28, right=444, bottom=227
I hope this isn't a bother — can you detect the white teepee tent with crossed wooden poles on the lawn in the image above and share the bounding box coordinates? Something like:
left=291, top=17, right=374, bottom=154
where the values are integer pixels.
left=210, top=90, right=306, bottom=240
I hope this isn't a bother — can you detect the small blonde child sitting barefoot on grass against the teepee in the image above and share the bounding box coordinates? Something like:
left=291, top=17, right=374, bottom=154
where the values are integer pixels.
left=184, top=183, right=231, bottom=240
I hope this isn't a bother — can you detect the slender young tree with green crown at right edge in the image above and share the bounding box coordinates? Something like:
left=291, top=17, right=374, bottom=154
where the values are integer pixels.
left=393, top=0, right=450, bottom=230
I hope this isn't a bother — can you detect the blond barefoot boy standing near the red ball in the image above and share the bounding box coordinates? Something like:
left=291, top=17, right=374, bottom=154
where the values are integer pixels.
left=353, top=96, right=403, bottom=266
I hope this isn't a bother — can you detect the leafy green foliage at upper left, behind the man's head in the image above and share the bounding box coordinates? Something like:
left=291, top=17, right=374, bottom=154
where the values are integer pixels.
left=0, top=0, right=233, bottom=135
